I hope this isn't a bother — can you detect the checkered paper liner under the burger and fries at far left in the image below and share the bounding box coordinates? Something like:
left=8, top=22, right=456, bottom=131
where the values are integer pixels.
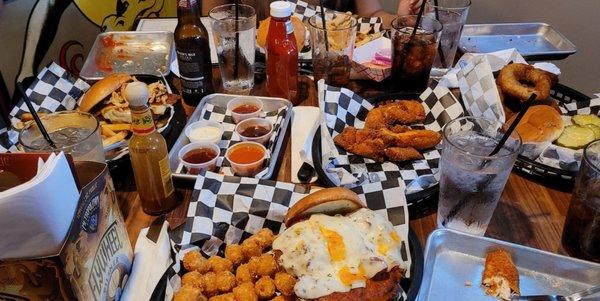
left=0, top=62, right=90, bottom=152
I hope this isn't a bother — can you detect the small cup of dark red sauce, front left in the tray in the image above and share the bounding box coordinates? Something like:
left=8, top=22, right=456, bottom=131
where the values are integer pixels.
left=177, top=142, right=221, bottom=175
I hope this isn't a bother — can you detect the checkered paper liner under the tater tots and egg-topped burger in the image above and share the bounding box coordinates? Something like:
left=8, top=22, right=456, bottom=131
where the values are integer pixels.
left=166, top=172, right=411, bottom=301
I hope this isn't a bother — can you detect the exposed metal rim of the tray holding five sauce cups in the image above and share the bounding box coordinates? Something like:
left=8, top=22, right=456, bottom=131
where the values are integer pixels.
left=169, top=93, right=293, bottom=181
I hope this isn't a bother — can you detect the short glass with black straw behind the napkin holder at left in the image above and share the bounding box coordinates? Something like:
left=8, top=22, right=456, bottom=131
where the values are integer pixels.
left=19, top=111, right=104, bottom=163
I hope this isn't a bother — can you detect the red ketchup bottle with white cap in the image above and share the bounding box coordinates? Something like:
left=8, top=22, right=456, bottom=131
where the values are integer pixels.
left=266, top=1, right=298, bottom=105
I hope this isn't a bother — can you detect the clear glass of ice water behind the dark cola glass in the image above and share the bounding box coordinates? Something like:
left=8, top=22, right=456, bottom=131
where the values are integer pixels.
left=427, top=0, right=471, bottom=78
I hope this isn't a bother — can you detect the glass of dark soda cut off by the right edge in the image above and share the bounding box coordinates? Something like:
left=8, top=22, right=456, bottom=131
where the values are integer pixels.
left=562, top=141, right=600, bottom=262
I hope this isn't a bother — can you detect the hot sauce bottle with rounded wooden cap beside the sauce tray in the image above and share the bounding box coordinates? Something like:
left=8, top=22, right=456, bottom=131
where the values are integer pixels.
left=123, top=82, right=178, bottom=215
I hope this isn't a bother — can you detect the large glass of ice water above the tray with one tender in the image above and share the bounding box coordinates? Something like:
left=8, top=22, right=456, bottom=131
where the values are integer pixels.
left=437, top=117, right=522, bottom=235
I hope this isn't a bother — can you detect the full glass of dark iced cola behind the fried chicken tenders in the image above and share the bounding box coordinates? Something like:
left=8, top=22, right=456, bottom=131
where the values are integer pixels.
left=392, top=15, right=442, bottom=92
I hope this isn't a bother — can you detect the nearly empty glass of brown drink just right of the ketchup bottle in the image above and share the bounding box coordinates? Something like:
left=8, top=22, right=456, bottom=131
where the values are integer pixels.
left=308, top=12, right=358, bottom=87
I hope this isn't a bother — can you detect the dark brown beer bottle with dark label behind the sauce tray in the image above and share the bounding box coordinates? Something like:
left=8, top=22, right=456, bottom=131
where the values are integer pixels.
left=175, top=0, right=214, bottom=107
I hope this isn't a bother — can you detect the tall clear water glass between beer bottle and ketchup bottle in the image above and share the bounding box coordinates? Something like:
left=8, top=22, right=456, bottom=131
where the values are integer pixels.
left=208, top=4, right=256, bottom=95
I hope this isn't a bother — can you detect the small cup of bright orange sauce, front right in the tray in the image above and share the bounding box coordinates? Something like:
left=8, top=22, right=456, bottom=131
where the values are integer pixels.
left=225, top=141, right=267, bottom=177
